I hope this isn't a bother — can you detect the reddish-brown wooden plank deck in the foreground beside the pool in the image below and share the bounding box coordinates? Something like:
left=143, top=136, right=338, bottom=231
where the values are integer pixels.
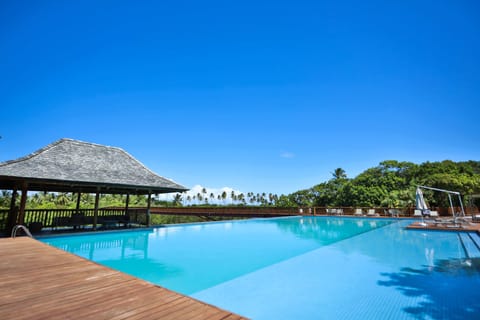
left=0, top=237, right=245, bottom=320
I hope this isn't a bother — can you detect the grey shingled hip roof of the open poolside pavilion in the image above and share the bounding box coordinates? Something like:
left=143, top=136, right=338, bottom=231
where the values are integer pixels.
left=0, top=139, right=187, bottom=194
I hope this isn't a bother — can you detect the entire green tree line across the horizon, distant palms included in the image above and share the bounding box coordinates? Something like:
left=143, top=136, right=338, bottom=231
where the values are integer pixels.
left=0, top=160, right=480, bottom=209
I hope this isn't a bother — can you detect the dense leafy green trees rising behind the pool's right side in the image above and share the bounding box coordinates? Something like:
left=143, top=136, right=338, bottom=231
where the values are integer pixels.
left=276, top=160, right=480, bottom=207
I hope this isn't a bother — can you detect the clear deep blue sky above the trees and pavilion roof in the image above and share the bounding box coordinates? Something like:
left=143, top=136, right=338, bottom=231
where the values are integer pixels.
left=0, top=0, right=480, bottom=194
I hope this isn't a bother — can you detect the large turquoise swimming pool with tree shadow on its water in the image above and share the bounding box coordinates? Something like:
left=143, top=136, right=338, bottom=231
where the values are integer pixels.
left=42, top=217, right=480, bottom=319
